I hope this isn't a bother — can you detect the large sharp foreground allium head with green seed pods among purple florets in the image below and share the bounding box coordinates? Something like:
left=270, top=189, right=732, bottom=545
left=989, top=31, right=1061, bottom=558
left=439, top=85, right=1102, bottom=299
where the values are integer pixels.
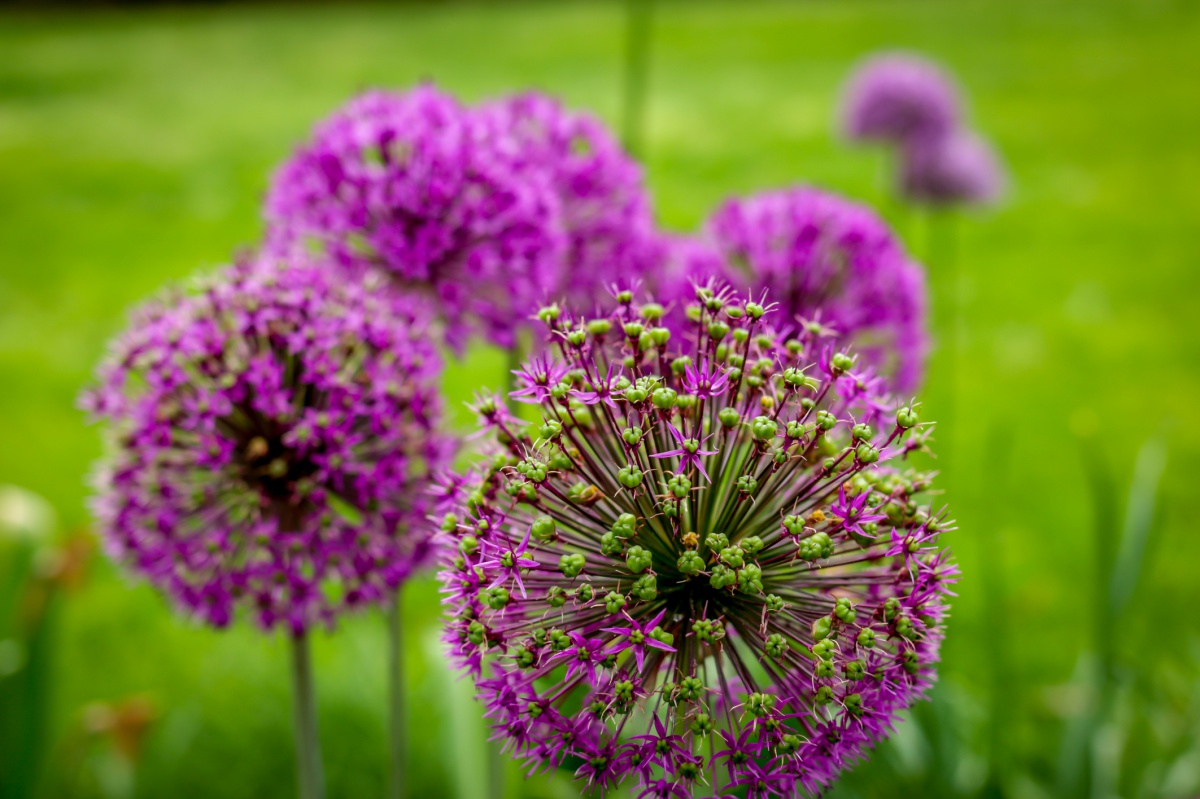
left=442, top=288, right=958, bottom=798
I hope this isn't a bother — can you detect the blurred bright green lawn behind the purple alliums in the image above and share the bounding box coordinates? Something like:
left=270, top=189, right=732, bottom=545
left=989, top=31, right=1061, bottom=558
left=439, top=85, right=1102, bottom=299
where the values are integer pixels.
left=0, top=0, right=1200, bottom=799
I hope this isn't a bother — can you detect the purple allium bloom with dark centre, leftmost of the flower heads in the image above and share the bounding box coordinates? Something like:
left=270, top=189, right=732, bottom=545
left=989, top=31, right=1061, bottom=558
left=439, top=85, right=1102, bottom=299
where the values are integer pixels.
left=82, top=253, right=452, bottom=633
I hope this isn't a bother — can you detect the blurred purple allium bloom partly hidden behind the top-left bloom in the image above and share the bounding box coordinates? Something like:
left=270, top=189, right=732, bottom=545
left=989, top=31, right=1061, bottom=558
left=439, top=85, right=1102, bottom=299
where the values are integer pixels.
left=480, top=92, right=655, bottom=316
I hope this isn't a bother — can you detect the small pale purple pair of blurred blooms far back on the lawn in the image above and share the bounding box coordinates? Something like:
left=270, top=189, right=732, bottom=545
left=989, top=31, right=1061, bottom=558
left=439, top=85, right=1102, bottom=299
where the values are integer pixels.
left=842, top=53, right=1004, bottom=205
